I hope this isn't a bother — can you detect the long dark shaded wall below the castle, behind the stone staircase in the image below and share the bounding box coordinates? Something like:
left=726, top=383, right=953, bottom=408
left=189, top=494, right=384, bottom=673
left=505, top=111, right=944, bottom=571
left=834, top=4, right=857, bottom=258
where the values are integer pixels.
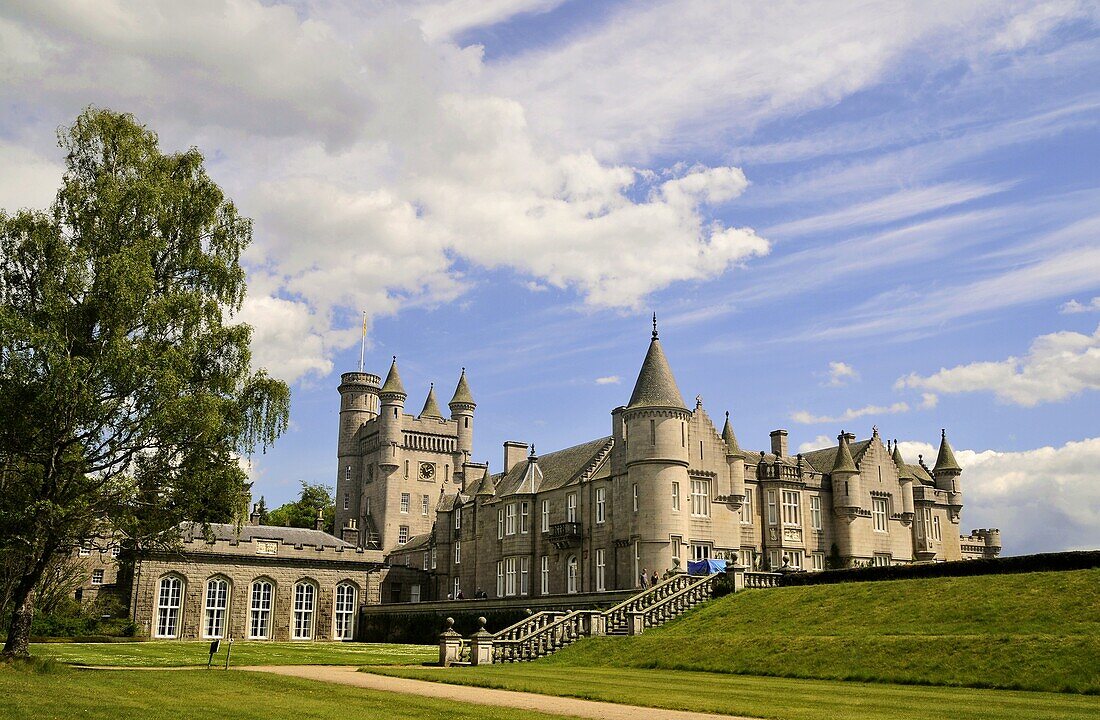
left=355, top=590, right=637, bottom=644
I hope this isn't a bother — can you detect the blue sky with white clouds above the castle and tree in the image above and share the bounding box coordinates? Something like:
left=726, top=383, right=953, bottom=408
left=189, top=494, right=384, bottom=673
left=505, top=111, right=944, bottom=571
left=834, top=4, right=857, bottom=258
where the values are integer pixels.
left=0, top=0, right=1100, bottom=553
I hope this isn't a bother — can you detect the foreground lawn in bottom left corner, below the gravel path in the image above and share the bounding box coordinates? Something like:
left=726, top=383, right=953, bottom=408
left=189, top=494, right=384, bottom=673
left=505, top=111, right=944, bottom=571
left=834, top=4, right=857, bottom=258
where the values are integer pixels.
left=0, top=663, right=585, bottom=720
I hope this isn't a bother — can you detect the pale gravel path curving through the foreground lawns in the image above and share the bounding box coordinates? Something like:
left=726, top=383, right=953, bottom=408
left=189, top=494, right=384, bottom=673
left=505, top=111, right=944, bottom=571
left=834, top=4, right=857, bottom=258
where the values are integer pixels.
left=237, top=665, right=747, bottom=720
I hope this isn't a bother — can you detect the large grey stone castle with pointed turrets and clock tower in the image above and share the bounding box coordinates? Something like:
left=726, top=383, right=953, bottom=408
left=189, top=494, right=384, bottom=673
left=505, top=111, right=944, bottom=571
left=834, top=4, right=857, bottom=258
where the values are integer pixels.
left=336, top=322, right=1000, bottom=601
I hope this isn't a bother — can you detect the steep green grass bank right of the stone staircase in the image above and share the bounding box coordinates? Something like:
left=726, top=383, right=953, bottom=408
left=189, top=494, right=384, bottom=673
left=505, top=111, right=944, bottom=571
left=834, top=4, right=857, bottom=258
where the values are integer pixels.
left=541, top=569, right=1100, bottom=694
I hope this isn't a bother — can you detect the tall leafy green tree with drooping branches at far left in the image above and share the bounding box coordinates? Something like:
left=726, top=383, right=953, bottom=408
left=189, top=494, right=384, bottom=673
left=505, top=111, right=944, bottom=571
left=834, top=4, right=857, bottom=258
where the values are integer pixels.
left=0, top=108, right=289, bottom=653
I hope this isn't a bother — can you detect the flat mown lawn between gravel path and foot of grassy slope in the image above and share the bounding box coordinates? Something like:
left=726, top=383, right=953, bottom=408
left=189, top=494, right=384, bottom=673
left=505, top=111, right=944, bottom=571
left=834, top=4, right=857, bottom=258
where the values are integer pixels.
left=370, top=663, right=1100, bottom=720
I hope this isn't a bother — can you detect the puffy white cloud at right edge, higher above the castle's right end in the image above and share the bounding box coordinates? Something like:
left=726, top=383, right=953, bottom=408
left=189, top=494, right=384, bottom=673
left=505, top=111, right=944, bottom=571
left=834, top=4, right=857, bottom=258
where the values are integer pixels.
left=894, top=325, right=1100, bottom=408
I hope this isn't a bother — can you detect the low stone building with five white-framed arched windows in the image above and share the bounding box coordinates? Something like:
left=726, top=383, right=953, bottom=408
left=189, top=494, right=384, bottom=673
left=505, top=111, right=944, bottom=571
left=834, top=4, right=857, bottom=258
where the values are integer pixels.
left=131, top=524, right=383, bottom=641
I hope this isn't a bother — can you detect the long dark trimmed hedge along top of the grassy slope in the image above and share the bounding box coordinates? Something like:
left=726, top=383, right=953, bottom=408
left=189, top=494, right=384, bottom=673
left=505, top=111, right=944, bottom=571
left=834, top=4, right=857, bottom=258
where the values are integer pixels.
left=780, top=550, right=1100, bottom=586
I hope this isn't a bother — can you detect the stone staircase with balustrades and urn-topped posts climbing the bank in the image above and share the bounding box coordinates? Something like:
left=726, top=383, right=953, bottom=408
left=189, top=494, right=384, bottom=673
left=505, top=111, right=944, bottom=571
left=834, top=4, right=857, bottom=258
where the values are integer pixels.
left=439, top=567, right=780, bottom=667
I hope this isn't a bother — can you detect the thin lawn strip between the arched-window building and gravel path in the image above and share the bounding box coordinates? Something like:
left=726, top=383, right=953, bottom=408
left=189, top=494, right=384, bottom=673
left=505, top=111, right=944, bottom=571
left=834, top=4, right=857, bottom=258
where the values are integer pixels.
left=31, top=641, right=439, bottom=667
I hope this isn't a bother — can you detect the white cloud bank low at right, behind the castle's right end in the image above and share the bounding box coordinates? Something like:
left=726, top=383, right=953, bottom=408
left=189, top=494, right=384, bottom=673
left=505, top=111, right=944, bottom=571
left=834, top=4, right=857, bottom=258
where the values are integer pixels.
left=900, top=437, right=1100, bottom=555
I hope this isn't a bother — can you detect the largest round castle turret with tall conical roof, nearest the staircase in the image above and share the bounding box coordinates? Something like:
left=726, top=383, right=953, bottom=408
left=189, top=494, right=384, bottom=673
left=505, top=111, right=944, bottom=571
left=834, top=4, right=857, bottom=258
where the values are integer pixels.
left=616, top=315, right=686, bottom=578
